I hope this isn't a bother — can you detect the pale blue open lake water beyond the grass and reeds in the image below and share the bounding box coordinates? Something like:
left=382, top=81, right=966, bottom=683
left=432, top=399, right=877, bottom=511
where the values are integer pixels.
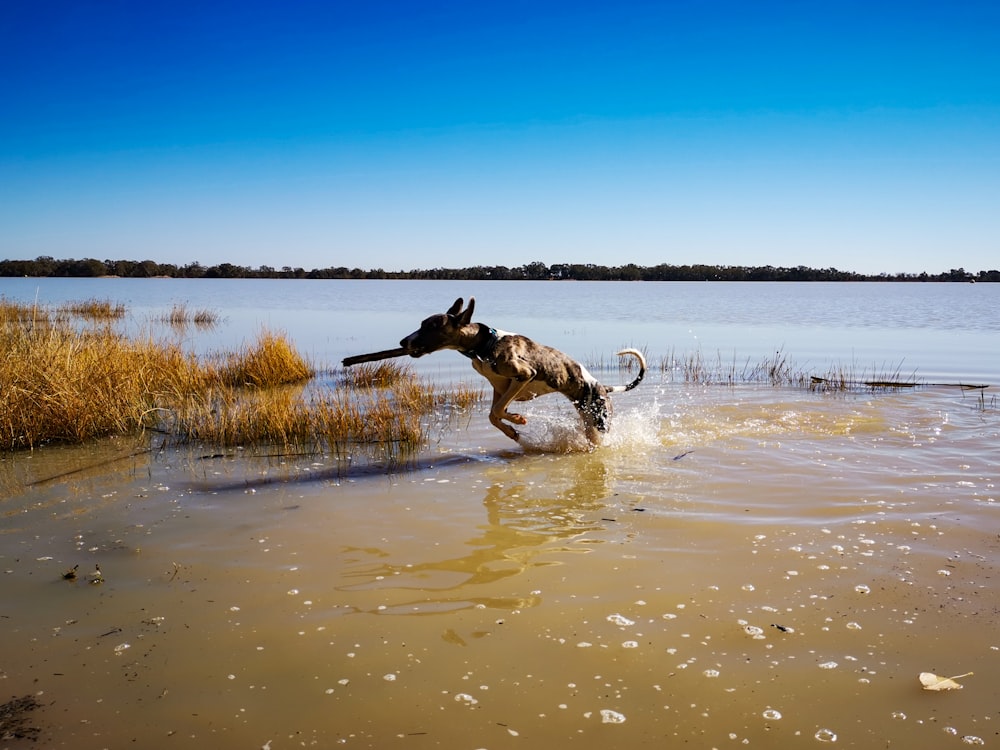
left=0, top=279, right=1000, bottom=383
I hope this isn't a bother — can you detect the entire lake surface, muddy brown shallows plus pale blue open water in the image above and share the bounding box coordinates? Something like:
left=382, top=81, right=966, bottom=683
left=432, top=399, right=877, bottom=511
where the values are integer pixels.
left=0, top=279, right=1000, bottom=750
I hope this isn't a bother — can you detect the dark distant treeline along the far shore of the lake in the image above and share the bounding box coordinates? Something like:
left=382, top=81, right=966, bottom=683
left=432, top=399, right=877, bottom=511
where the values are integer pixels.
left=0, top=256, right=1000, bottom=282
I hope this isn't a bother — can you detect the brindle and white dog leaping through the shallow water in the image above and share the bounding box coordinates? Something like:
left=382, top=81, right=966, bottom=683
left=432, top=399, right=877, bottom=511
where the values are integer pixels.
left=399, top=297, right=646, bottom=446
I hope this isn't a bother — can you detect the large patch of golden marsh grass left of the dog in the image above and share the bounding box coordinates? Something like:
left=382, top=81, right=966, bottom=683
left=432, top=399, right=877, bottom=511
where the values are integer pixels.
left=0, top=300, right=482, bottom=459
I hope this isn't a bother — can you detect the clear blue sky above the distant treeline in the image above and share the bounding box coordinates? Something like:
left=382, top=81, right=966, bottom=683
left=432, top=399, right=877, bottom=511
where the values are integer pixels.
left=0, top=0, right=1000, bottom=273
